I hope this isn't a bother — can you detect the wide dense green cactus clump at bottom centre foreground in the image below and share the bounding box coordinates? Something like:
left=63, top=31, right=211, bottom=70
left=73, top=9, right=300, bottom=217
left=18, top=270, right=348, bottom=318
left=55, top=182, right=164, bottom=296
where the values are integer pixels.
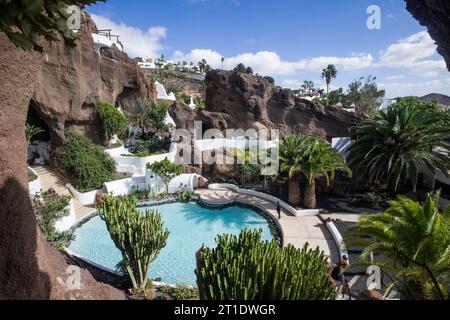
left=196, top=230, right=335, bottom=300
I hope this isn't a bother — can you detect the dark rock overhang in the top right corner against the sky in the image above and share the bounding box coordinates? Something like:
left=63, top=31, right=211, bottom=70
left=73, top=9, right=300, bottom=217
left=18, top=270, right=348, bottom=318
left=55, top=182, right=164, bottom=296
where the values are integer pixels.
left=405, top=0, right=450, bottom=71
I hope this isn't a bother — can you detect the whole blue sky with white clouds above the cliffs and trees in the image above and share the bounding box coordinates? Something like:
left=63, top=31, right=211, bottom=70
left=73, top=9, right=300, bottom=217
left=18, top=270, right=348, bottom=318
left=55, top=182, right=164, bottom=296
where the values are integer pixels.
left=88, top=0, right=450, bottom=97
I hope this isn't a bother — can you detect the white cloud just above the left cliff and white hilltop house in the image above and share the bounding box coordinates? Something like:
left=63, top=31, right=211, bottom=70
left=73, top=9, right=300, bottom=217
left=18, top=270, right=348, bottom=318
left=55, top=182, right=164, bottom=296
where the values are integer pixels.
left=91, top=14, right=167, bottom=57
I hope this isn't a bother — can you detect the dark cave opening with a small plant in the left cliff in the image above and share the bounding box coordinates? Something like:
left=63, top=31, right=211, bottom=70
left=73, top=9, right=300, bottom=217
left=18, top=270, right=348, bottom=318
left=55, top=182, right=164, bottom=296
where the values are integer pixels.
left=25, top=101, right=52, bottom=165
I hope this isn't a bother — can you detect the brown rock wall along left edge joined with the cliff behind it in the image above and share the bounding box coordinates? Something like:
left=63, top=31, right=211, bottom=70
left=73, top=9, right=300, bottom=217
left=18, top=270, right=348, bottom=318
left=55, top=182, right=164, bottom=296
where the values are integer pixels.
left=0, top=10, right=154, bottom=300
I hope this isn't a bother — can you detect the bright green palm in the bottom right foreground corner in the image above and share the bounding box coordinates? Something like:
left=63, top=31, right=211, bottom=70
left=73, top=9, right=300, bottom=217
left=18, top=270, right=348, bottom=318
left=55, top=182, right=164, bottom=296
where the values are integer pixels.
left=346, top=192, right=450, bottom=300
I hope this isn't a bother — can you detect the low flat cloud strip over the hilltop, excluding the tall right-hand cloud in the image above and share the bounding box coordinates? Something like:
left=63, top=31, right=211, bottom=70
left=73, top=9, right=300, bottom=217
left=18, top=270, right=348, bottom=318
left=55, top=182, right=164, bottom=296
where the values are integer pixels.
left=173, top=49, right=373, bottom=76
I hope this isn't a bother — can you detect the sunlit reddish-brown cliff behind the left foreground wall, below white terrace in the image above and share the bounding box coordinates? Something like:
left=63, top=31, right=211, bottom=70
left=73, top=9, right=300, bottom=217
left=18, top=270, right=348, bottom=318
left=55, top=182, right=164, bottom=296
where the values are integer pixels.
left=30, top=13, right=155, bottom=146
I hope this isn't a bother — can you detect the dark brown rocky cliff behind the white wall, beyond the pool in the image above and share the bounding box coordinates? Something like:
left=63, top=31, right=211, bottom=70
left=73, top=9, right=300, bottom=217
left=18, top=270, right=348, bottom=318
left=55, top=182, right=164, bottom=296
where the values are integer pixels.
left=171, top=71, right=361, bottom=139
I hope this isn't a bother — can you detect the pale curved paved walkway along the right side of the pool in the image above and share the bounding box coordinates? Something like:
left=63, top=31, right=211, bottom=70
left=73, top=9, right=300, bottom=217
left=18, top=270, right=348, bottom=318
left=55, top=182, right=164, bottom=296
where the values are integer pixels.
left=196, top=189, right=339, bottom=262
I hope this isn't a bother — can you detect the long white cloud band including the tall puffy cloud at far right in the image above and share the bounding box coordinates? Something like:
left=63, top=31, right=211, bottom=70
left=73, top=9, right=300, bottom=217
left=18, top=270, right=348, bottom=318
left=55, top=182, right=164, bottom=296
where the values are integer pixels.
left=173, top=32, right=446, bottom=80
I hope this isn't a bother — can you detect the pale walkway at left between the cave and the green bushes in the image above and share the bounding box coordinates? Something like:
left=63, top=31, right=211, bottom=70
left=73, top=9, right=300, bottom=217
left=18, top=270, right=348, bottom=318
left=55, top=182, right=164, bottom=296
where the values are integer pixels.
left=32, top=166, right=95, bottom=219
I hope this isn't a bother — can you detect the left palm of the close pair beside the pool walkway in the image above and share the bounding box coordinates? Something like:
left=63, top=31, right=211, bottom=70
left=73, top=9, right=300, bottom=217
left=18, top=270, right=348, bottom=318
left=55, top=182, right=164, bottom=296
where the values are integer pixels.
left=280, top=136, right=302, bottom=206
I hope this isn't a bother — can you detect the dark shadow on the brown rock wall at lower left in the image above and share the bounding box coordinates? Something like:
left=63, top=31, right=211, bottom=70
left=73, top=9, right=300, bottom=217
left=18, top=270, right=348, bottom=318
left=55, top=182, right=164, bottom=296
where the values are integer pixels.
left=0, top=178, right=52, bottom=300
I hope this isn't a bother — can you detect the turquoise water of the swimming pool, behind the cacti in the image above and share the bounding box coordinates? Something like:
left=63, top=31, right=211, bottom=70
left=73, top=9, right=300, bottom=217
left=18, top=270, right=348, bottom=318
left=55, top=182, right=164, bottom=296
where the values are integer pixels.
left=69, top=203, right=274, bottom=285
